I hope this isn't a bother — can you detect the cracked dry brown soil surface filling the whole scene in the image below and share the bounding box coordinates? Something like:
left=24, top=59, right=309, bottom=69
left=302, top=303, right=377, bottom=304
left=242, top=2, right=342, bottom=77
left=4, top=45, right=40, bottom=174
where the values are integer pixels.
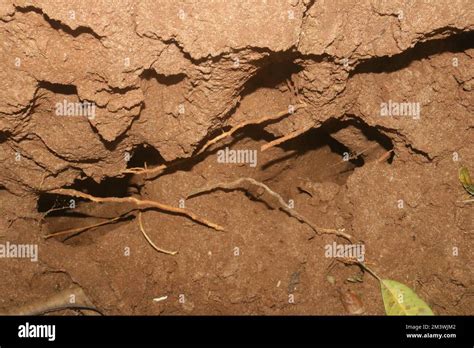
left=0, top=0, right=474, bottom=315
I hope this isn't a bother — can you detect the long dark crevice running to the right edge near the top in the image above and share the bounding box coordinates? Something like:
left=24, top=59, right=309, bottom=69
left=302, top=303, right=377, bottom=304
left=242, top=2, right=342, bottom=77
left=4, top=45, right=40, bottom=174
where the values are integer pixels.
left=349, top=30, right=474, bottom=77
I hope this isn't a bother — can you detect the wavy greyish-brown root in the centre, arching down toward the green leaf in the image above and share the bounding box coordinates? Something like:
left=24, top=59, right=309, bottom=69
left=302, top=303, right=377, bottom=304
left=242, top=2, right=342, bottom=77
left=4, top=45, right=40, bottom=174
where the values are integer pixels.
left=187, top=178, right=353, bottom=241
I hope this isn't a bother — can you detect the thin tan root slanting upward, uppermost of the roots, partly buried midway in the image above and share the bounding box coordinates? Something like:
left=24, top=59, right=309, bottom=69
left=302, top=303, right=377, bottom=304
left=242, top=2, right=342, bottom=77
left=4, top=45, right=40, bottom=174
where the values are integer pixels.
left=122, top=103, right=306, bottom=175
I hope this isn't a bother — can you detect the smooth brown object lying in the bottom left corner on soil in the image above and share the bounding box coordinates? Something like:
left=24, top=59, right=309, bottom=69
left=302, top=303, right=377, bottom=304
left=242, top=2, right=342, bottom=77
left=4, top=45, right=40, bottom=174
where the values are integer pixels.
left=0, top=286, right=103, bottom=315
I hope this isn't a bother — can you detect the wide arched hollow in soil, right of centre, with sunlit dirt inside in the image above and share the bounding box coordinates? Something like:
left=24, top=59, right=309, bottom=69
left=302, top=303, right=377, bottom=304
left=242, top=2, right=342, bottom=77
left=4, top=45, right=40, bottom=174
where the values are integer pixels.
left=261, top=115, right=393, bottom=197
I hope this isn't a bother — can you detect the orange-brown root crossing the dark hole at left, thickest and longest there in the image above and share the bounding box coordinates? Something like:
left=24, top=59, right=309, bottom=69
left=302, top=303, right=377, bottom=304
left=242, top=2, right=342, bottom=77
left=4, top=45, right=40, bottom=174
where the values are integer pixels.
left=49, top=189, right=224, bottom=231
